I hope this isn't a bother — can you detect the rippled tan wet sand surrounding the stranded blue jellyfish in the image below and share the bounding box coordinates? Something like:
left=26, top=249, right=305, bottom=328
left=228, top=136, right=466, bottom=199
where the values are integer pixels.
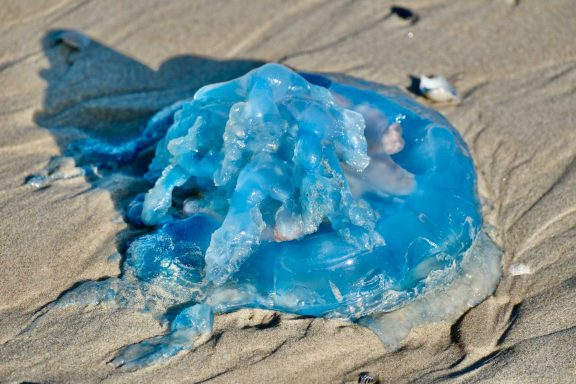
left=0, top=0, right=576, bottom=383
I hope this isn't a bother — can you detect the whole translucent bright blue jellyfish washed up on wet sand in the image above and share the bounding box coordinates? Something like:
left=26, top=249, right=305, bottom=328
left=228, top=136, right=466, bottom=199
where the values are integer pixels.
left=30, top=64, right=501, bottom=369
